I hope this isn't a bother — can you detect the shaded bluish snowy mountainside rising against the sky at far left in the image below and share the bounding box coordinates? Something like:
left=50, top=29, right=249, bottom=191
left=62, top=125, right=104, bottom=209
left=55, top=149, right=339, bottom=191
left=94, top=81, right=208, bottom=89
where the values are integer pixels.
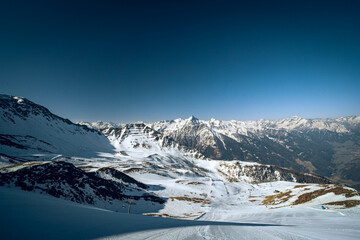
left=0, top=95, right=113, bottom=157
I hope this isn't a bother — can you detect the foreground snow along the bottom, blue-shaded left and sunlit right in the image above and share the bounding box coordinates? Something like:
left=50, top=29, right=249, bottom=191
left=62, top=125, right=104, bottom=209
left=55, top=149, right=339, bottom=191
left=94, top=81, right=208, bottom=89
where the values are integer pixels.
left=0, top=187, right=360, bottom=239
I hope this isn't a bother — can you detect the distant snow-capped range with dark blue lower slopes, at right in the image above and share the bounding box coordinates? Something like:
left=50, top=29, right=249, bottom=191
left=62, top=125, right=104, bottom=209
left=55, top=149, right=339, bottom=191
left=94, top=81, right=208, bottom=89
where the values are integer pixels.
left=148, top=116, right=360, bottom=188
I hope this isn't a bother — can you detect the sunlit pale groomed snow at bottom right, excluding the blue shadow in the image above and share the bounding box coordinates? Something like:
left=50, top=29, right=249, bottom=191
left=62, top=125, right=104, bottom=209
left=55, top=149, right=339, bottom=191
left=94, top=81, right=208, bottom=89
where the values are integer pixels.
left=115, top=194, right=360, bottom=240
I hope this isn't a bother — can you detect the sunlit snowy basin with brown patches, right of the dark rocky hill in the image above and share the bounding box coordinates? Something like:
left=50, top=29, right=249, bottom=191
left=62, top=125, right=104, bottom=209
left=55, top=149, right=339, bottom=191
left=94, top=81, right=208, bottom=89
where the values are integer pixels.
left=54, top=152, right=360, bottom=219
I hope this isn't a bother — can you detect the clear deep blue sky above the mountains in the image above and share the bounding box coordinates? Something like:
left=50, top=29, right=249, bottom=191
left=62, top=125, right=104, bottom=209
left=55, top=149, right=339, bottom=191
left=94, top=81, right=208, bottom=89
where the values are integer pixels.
left=0, top=0, right=360, bottom=122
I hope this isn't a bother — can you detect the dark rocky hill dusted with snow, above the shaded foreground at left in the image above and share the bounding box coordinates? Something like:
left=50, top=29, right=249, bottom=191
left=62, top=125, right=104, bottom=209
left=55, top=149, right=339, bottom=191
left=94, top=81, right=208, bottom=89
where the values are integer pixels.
left=0, top=161, right=164, bottom=207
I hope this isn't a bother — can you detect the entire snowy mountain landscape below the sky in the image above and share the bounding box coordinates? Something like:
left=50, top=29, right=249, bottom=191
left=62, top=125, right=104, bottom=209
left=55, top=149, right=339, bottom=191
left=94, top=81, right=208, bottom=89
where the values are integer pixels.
left=0, top=95, right=360, bottom=239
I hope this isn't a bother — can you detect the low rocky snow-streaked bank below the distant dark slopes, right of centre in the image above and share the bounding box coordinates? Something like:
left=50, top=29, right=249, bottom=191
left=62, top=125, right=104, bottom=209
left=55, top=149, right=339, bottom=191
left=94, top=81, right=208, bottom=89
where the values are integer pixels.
left=219, top=162, right=331, bottom=184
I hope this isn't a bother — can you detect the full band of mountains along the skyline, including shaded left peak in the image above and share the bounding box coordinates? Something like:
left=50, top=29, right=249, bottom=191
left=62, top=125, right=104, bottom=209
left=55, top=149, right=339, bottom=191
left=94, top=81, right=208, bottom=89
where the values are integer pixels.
left=0, top=95, right=360, bottom=188
